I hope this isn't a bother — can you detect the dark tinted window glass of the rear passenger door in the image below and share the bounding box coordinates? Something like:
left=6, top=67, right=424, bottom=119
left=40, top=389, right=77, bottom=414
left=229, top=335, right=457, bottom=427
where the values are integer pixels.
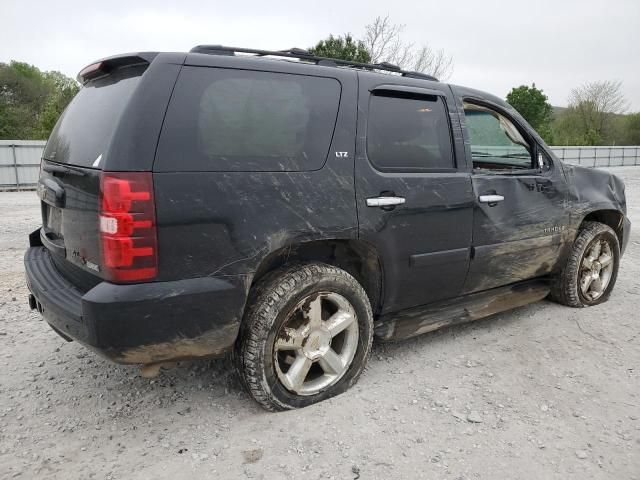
left=367, top=92, right=454, bottom=171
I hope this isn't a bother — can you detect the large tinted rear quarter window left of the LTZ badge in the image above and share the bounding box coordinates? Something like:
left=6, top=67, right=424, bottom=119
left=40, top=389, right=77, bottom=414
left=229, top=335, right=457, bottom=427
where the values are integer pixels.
left=156, top=67, right=340, bottom=171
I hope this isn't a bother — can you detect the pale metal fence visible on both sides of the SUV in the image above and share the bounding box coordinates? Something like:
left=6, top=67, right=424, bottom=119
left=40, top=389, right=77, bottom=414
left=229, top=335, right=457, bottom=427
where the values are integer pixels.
left=0, top=140, right=640, bottom=189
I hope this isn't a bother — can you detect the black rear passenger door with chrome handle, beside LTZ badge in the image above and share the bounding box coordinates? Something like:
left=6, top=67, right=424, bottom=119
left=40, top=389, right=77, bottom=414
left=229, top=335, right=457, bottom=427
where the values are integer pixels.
left=355, top=73, right=473, bottom=313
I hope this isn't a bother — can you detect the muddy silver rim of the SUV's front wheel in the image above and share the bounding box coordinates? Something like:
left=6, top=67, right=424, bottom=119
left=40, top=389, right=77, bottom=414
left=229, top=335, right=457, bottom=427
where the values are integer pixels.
left=580, top=238, right=614, bottom=301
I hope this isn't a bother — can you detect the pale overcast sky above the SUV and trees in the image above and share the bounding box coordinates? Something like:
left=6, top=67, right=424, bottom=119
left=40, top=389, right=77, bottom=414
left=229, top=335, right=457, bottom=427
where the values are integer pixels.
left=5, top=0, right=640, bottom=111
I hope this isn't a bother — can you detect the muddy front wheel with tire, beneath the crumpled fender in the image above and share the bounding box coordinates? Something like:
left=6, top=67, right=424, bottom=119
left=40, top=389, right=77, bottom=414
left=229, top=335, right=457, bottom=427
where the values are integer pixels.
left=551, top=222, right=620, bottom=308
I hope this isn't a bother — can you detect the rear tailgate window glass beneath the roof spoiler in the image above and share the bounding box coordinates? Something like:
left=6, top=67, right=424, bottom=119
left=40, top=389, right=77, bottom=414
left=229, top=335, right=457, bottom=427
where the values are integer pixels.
left=44, top=64, right=148, bottom=168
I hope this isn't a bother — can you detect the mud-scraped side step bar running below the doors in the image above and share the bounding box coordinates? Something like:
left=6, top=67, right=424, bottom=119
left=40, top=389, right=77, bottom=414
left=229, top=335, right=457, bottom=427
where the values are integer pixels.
left=375, top=279, right=549, bottom=341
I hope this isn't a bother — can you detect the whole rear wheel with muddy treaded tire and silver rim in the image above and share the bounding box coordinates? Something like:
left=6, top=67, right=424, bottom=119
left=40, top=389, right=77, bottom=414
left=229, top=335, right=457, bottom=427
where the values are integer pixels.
left=236, top=263, right=373, bottom=410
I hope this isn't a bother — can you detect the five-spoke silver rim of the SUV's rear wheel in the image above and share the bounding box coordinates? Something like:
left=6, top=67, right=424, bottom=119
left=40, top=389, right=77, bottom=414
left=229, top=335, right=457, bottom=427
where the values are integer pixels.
left=273, top=292, right=359, bottom=395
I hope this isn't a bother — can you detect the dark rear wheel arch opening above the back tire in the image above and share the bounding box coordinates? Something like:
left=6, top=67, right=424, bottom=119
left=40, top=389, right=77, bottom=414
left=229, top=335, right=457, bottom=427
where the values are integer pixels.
left=251, top=239, right=383, bottom=315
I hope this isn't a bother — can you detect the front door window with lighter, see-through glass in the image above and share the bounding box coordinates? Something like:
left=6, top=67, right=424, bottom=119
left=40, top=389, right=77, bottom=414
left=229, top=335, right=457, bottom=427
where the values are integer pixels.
left=464, top=102, right=533, bottom=170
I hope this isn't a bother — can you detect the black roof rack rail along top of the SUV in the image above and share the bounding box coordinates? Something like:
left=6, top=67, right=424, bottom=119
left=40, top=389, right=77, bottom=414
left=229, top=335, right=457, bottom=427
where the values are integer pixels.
left=189, top=45, right=438, bottom=82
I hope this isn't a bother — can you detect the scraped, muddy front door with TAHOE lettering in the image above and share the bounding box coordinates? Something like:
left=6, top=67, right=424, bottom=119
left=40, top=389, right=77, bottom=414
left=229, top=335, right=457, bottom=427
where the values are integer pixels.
left=462, top=93, right=569, bottom=293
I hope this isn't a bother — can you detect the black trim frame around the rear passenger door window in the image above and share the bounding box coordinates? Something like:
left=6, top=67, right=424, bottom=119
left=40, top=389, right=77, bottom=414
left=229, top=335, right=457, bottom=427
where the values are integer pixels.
left=364, top=88, right=460, bottom=174
